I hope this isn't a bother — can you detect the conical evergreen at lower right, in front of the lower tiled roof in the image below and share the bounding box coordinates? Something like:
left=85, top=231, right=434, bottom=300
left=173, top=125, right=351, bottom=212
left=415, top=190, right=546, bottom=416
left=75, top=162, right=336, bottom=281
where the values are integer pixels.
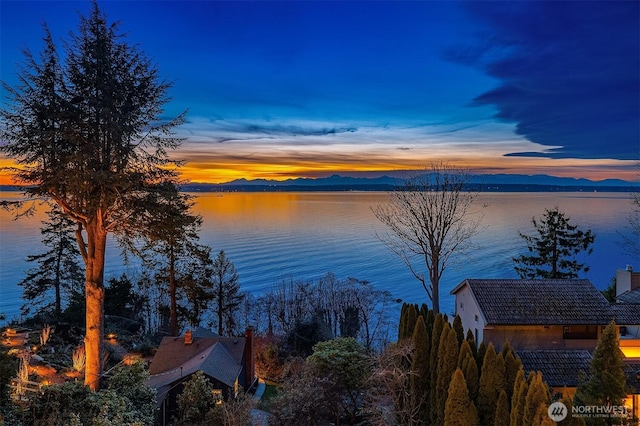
left=575, top=321, right=627, bottom=424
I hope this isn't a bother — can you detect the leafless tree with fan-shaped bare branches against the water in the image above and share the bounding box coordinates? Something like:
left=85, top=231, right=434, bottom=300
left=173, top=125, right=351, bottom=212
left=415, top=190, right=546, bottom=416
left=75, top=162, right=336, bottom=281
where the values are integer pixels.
left=373, top=161, right=482, bottom=313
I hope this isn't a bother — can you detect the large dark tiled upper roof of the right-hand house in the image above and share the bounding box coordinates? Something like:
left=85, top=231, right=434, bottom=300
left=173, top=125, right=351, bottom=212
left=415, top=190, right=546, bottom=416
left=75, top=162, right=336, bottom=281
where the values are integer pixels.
left=451, top=279, right=614, bottom=325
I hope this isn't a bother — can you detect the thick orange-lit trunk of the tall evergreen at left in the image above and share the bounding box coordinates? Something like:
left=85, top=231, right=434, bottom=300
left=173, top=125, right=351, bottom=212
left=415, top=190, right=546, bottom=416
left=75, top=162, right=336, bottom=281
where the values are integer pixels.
left=81, top=219, right=107, bottom=391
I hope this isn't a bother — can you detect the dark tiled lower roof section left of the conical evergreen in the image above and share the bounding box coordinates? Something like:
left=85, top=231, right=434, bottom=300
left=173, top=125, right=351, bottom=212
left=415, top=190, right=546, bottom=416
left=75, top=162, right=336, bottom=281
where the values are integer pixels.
left=516, top=349, right=592, bottom=387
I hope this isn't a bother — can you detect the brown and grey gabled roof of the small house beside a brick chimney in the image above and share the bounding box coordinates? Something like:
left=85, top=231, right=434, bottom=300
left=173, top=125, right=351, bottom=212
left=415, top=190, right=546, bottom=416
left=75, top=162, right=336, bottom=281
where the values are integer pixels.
left=146, top=336, right=246, bottom=401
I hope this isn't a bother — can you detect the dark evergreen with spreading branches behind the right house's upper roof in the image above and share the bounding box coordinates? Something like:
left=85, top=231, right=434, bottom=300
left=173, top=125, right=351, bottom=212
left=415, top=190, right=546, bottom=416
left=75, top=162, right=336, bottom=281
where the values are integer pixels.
left=513, top=207, right=595, bottom=279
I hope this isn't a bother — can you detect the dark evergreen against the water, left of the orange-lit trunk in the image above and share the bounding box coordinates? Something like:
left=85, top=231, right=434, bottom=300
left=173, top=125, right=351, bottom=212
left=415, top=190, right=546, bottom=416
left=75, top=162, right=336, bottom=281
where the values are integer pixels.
left=18, top=205, right=84, bottom=319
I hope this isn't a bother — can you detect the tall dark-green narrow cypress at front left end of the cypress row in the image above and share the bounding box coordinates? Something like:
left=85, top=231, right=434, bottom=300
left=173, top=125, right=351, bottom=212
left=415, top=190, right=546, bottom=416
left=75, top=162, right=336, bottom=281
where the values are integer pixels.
left=410, top=315, right=431, bottom=419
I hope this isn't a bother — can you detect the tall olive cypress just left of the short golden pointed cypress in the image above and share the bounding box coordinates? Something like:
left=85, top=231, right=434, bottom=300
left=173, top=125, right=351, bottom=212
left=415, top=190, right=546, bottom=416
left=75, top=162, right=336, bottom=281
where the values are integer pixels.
left=436, top=324, right=458, bottom=425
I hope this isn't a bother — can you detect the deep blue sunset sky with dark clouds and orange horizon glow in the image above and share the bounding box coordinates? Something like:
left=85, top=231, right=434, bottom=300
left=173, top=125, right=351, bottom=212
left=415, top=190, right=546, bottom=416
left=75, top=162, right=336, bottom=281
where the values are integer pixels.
left=0, top=0, right=640, bottom=183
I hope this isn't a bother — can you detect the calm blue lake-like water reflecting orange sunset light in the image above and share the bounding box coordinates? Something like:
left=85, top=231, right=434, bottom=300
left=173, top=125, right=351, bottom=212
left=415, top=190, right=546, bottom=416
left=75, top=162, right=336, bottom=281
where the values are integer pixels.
left=0, top=192, right=640, bottom=318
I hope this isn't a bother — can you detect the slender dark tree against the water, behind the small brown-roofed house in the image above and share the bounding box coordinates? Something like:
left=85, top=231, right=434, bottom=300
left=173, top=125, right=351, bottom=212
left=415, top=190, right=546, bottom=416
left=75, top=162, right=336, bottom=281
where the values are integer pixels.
left=213, top=250, right=244, bottom=336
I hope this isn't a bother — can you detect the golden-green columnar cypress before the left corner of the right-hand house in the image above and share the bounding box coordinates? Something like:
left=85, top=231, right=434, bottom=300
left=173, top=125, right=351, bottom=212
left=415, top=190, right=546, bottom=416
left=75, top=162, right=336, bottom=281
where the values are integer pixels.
left=477, top=343, right=505, bottom=425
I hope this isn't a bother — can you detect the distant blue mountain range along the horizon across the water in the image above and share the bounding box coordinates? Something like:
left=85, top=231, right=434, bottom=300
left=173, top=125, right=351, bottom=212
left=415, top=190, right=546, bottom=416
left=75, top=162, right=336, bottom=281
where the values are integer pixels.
left=0, top=174, right=640, bottom=192
